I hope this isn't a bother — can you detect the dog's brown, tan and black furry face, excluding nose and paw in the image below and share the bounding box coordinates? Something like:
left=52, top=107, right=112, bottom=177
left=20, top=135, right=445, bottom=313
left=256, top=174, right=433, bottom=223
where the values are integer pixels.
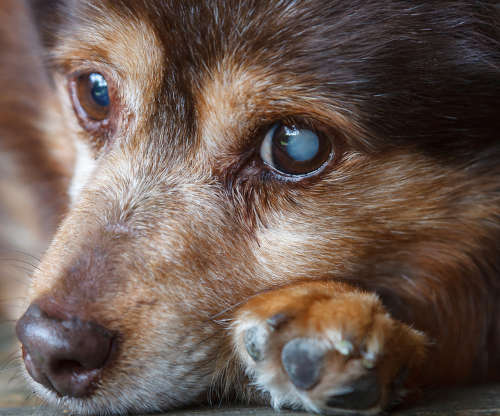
left=17, top=0, right=500, bottom=412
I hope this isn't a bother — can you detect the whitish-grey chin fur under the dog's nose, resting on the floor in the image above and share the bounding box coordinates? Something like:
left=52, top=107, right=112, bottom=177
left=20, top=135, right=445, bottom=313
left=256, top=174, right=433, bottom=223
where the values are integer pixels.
left=23, top=362, right=206, bottom=415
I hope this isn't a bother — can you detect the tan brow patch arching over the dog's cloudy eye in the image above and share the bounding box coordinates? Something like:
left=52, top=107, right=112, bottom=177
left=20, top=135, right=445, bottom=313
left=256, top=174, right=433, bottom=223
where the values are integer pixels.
left=196, top=57, right=362, bottom=164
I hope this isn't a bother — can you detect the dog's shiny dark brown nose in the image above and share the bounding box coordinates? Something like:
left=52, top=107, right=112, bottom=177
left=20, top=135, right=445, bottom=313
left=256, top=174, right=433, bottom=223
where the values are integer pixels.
left=16, top=304, right=113, bottom=397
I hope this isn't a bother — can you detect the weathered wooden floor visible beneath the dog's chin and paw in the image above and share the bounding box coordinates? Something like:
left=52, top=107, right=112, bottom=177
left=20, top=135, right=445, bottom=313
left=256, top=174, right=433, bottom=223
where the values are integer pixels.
left=0, top=324, right=500, bottom=416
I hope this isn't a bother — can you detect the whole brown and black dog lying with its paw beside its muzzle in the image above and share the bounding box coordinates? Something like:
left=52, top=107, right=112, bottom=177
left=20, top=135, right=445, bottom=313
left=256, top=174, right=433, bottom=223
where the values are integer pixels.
left=1, top=0, right=500, bottom=415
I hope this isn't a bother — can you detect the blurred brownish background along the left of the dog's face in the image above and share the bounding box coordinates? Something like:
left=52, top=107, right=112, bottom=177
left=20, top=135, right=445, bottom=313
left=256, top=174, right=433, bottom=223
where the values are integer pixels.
left=0, top=0, right=71, bottom=407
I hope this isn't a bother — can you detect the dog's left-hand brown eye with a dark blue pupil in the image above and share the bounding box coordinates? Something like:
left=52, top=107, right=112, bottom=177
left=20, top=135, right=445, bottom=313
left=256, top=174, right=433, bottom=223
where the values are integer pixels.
left=71, top=72, right=111, bottom=129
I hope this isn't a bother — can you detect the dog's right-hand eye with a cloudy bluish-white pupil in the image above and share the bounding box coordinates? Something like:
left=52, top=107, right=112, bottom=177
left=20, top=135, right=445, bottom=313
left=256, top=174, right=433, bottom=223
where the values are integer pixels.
left=260, top=123, right=333, bottom=176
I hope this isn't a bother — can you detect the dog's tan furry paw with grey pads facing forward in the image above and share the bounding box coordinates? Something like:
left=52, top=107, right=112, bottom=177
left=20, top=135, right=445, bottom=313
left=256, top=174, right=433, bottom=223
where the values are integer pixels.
left=233, top=283, right=425, bottom=415
